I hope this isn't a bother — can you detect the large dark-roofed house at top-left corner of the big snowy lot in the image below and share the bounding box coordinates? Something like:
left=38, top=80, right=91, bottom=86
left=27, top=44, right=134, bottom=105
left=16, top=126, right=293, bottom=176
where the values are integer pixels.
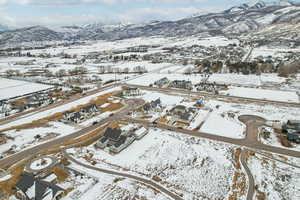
left=96, top=128, right=135, bottom=153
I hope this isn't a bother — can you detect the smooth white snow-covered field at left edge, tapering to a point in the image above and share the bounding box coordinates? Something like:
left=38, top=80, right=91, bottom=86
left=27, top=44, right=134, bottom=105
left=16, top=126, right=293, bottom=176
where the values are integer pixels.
left=0, top=78, right=53, bottom=100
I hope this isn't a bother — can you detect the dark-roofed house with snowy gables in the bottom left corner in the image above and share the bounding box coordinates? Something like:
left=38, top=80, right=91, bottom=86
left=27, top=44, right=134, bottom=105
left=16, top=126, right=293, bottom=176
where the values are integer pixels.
left=16, top=173, right=64, bottom=200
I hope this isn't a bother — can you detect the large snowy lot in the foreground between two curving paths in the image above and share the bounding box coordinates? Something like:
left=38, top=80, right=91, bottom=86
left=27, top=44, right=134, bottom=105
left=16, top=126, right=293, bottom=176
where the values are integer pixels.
left=68, top=129, right=234, bottom=200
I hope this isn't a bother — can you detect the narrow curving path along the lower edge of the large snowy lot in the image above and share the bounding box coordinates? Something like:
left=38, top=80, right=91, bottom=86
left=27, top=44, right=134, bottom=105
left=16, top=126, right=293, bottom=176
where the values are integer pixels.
left=64, top=152, right=183, bottom=200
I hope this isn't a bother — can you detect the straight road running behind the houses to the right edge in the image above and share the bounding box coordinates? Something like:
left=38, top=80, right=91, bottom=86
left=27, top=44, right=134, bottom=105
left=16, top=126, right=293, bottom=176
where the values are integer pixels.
left=123, top=84, right=300, bottom=107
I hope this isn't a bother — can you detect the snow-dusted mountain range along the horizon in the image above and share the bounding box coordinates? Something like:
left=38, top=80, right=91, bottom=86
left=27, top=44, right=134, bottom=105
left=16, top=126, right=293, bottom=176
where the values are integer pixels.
left=0, top=1, right=300, bottom=48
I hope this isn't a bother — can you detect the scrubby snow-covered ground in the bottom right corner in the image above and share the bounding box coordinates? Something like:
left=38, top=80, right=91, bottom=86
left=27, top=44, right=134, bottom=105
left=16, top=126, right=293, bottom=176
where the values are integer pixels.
left=248, top=154, right=300, bottom=200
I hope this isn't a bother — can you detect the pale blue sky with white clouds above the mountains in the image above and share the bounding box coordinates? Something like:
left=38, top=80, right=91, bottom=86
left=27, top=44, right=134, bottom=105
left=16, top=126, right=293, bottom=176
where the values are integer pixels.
left=0, top=0, right=296, bottom=28
